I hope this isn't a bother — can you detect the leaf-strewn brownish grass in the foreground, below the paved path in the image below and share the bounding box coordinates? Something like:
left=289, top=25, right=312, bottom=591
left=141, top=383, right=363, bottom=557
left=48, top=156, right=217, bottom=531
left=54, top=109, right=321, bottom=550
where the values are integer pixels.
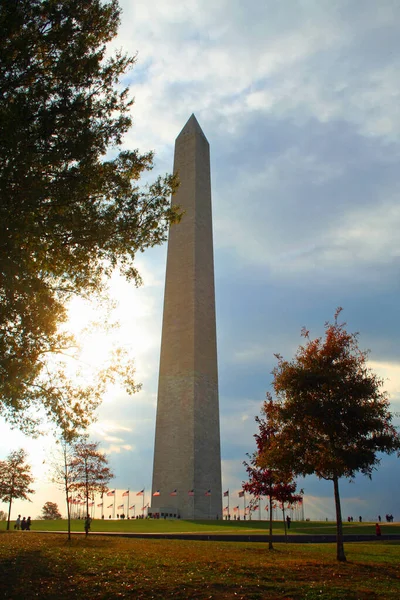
left=0, top=531, right=400, bottom=600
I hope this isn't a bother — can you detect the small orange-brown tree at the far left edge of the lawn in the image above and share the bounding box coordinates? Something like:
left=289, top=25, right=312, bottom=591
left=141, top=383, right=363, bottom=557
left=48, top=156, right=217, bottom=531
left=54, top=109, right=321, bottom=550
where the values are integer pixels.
left=0, top=448, right=34, bottom=529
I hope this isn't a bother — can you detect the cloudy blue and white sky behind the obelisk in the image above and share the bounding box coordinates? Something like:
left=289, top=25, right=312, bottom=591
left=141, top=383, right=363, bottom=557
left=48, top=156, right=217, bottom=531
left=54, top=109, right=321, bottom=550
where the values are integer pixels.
left=0, top=0, right=400, bottom=520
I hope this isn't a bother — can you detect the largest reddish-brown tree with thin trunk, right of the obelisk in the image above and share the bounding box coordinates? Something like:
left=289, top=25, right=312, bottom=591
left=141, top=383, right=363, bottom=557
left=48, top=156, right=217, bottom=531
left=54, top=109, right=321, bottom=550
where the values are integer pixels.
left=264, top=308, right=400, bottom=561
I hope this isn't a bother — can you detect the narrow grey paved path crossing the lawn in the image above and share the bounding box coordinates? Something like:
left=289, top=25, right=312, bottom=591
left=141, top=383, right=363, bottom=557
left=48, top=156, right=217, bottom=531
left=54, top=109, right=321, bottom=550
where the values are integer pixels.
left=34, top=530, right=400, bottom=544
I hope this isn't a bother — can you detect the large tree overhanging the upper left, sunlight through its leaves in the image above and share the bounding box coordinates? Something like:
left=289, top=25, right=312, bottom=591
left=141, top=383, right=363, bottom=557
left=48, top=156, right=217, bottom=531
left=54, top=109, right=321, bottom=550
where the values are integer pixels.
left=0, top=0, right=179, bottom=431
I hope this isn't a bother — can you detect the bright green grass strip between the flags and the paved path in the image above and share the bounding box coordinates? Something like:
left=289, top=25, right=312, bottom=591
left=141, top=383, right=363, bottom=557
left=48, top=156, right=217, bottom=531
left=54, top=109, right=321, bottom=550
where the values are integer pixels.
left=0, top=519, right=400, bottom=535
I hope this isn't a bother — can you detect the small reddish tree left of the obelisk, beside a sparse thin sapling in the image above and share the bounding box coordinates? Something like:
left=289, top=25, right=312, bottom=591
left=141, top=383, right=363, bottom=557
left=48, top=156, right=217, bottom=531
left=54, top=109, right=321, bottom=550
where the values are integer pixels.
left=68, top=440, right=114, bottom=515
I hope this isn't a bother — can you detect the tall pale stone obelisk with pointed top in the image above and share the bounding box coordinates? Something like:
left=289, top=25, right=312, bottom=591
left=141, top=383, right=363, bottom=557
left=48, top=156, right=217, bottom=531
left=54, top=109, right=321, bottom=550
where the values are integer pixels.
left=151, top=115, right=222, bottom=519
